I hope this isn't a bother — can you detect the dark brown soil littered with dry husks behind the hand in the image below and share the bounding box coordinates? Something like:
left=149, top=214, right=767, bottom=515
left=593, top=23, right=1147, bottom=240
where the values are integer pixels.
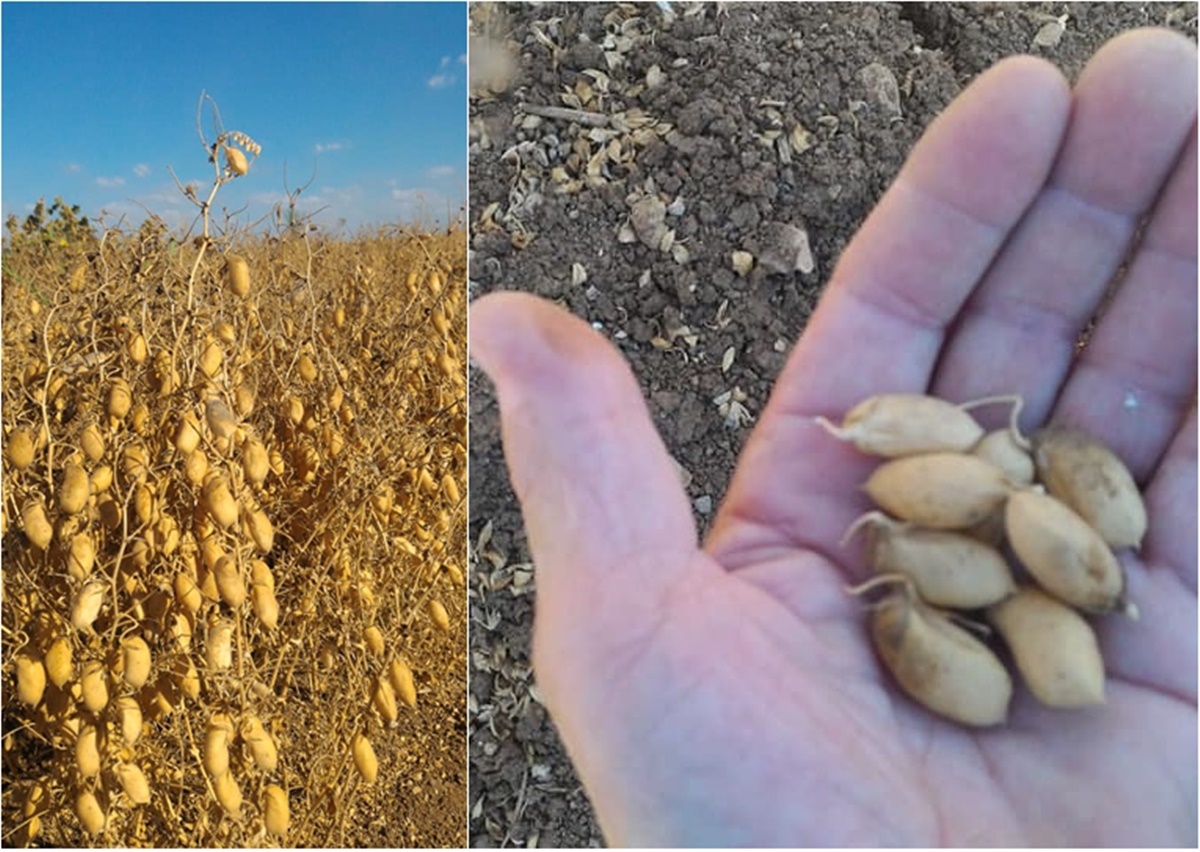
left=468, top=2, right=1196, bottom=846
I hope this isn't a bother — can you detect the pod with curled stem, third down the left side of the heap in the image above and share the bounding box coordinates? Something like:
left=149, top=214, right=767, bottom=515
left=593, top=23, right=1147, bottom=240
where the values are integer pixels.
left=851, top=512, right=1016, bottom=610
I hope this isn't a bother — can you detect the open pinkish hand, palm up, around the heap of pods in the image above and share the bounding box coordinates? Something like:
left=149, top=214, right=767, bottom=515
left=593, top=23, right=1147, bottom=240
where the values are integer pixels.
left=470, top=30, right=1196, bottom=846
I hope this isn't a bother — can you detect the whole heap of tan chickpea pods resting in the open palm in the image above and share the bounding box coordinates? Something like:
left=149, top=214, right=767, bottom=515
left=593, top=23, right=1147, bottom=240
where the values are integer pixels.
left=816, top=394, right=1146, bottom=727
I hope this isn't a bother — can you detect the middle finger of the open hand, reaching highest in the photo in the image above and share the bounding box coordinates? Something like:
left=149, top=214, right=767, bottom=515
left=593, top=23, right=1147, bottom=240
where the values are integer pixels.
left=934, top=30, right=1196, bottom=444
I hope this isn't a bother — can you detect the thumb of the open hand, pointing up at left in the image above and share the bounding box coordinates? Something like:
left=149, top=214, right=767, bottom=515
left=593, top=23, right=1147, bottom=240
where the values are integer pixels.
left=469, top=293, right=696, bottom=642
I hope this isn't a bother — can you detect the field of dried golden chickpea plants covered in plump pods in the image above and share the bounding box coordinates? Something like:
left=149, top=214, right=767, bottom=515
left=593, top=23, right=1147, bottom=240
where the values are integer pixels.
left=0, top=101, right=467, bottom=847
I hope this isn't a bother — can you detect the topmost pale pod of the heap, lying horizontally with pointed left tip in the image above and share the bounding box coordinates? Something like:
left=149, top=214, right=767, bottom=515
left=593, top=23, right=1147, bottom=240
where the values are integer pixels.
left=816, top=394, right=983, bottom=458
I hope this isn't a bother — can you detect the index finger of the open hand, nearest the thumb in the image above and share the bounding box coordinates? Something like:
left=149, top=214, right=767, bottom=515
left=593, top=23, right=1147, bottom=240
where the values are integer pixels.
left=709, top=58, right=1069, bottom=571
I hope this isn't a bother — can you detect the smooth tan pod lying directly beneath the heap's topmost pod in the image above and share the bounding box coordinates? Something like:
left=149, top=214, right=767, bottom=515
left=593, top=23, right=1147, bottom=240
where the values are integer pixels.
left=865, top=452, right=1012, bottom=529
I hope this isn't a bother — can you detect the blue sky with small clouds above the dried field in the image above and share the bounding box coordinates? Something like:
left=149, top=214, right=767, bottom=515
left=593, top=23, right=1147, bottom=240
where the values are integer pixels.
left=0, top=2, right=467, bottom=230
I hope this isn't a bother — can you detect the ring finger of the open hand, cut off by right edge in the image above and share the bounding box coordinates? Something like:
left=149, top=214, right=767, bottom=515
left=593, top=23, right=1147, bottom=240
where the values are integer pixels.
left=1055, top=125, right=1196, bottom=480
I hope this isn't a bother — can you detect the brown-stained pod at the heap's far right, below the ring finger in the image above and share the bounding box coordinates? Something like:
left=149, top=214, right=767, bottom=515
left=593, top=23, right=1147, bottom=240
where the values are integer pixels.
left=1033, top=426, right=1146, bottom=548
